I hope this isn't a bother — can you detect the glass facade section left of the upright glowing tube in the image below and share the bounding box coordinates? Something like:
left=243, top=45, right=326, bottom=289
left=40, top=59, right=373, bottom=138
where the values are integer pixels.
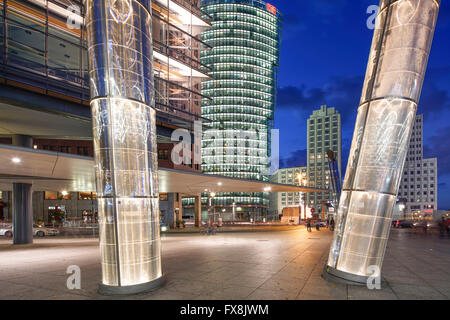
left=0, top=0, right=89, bottom=100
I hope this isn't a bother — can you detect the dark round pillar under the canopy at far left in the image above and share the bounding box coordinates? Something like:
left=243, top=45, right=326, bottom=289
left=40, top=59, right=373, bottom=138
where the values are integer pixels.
left=12, top=183, right=33, bottom=244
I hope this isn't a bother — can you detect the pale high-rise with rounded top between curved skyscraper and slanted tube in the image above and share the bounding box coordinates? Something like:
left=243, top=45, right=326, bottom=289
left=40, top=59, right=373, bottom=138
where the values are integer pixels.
left=307, top=106, right=342, bottom=215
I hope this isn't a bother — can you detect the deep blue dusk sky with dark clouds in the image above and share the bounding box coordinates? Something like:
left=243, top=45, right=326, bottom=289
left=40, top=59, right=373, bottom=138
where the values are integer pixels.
left=269, top=0, right=450, bottom=209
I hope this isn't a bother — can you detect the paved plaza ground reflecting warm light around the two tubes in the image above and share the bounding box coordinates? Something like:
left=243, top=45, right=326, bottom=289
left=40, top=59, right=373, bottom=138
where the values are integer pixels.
left=0, top=226, right=450, bottom=300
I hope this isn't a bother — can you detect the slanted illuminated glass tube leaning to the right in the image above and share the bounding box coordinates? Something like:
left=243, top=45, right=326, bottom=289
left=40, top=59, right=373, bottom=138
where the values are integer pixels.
left=324, top=0, right=440, bottom=283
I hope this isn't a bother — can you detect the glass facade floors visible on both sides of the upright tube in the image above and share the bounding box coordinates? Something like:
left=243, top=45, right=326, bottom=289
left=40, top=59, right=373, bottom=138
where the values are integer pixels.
left=0, top=0, right=210, bottom=129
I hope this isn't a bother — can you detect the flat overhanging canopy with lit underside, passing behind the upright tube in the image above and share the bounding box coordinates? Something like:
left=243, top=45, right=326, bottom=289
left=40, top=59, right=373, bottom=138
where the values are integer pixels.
left=0, top=145, right=327, bottom=195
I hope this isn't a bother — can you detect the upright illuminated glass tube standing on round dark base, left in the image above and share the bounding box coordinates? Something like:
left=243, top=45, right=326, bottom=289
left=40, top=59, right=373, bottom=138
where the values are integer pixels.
left=86, top=0, right=163, bottom=294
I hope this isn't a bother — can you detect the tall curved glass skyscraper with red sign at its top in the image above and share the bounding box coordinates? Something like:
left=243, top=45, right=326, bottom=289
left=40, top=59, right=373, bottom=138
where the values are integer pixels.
left=201, top=0, right=281, bottom=218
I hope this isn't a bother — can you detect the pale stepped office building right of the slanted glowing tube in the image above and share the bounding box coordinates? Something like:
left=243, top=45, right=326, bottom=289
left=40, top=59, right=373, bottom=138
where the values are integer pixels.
left=398, top=114, right=438, bottom=218
